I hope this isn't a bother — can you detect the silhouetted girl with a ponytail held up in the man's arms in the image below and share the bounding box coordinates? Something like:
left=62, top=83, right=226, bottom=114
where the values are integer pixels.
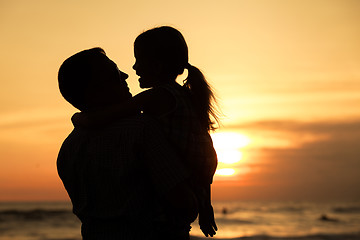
left=78, top=26, right=217, bottom=237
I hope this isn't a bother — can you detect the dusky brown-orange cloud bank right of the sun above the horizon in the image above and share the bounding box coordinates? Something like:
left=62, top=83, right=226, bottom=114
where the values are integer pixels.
left=221, top=120, right=360, bottom=199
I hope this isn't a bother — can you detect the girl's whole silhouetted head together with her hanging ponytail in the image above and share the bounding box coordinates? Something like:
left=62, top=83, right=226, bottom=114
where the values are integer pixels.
left=133, top=26, right=217, bottom=130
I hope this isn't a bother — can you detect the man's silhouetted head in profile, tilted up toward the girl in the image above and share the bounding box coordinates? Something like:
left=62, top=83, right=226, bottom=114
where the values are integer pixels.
left=58, top=48, right=131, bottom=111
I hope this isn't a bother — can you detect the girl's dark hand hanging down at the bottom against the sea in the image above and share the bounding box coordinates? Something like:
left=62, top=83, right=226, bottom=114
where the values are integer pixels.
left=199, top=205, right=217, bottom=237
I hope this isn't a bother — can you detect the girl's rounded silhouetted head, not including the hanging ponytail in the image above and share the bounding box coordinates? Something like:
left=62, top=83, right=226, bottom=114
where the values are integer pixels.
left=133, top=26, right=189, bottom=88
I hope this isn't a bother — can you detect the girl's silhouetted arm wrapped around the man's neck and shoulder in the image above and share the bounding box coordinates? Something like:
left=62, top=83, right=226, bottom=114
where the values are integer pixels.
left=72, top=88, right=176, bottom=127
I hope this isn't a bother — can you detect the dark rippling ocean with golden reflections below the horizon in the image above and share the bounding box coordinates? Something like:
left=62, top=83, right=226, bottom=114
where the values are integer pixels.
left=0, top=201, right=360, bottom=240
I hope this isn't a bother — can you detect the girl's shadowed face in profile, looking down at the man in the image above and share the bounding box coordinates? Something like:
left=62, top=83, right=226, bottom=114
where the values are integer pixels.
left=133, top=48, right=161, bottom=88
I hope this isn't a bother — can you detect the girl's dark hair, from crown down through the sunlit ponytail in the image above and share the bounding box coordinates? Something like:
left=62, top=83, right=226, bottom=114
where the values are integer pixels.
left=134, top=26, right=218, bottom=130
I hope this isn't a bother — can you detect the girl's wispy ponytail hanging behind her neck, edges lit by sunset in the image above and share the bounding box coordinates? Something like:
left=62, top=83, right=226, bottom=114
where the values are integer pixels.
left=184, top=63, right=219, bottom=131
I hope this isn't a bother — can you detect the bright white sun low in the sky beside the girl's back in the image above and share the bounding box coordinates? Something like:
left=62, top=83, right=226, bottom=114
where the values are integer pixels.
left=211, top=132, right=250, bottom=176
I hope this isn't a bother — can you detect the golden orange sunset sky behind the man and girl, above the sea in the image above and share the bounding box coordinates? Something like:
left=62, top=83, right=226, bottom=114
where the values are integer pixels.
left=0, top=0, right=360, bottom=201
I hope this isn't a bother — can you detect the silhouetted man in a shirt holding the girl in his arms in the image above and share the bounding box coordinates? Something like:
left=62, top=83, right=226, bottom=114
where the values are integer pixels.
left=57, top=48, right=197, bottom=240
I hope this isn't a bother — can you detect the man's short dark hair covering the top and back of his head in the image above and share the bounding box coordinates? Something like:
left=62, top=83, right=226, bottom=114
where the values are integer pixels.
left=58, top=47, right=105, bottom=111
